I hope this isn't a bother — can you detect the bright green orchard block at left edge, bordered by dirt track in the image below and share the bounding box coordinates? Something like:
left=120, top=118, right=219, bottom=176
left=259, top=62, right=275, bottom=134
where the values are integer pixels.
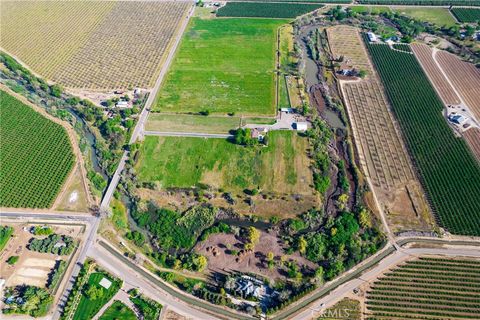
left=0, top=90, right=75, bottom=208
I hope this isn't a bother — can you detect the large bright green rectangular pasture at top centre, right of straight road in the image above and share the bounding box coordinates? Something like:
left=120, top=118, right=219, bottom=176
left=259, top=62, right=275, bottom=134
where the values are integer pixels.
left=153, top=18, right=288, bottom=115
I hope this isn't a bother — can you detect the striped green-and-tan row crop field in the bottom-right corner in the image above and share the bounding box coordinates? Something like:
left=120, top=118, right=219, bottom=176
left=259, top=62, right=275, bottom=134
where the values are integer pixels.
left=366, top=257, right=480, bottom=320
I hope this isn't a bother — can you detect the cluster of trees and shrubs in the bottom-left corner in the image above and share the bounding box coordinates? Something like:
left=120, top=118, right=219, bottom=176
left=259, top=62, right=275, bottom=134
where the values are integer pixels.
left=2, top=285, right=53, bottom=318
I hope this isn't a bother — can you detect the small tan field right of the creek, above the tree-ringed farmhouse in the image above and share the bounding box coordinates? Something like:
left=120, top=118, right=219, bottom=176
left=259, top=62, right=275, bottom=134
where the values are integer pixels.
left=326, top=25, right=372, bottom=73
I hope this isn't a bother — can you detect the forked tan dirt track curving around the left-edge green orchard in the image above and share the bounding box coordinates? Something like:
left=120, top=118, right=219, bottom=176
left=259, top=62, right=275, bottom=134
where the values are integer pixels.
left=0, top=83, right=93, bottom=210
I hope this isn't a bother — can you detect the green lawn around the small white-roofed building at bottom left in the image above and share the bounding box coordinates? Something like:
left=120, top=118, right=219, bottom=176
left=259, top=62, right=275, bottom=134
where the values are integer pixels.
left=73, top=272, right=121, bottom=320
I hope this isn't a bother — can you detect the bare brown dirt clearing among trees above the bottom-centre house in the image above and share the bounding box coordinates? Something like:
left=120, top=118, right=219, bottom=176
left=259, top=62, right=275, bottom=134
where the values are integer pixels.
left=194, top=231, right=316, bottom=279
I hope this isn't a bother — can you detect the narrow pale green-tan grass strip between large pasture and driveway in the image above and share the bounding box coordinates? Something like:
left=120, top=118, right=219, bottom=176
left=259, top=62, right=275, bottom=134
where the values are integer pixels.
left=145, top=113, right=240, bottom=133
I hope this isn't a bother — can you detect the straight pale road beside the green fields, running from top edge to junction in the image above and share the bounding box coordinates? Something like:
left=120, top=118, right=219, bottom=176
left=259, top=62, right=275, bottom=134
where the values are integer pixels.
left=100, top=2, right=195, bottom=211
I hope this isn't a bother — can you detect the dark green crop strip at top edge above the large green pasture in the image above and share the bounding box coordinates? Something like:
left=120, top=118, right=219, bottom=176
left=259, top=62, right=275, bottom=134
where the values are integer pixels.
left=217, top=2, right=323, bottom=18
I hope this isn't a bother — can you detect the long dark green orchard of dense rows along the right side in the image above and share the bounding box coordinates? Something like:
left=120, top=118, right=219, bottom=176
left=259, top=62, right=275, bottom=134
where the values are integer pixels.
left=365, top=39, right=480, bottom=235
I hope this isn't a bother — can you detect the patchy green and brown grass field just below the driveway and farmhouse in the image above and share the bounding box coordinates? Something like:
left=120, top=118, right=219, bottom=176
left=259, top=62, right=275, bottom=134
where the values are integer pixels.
left=137, top=131, right=312, bottom=194
